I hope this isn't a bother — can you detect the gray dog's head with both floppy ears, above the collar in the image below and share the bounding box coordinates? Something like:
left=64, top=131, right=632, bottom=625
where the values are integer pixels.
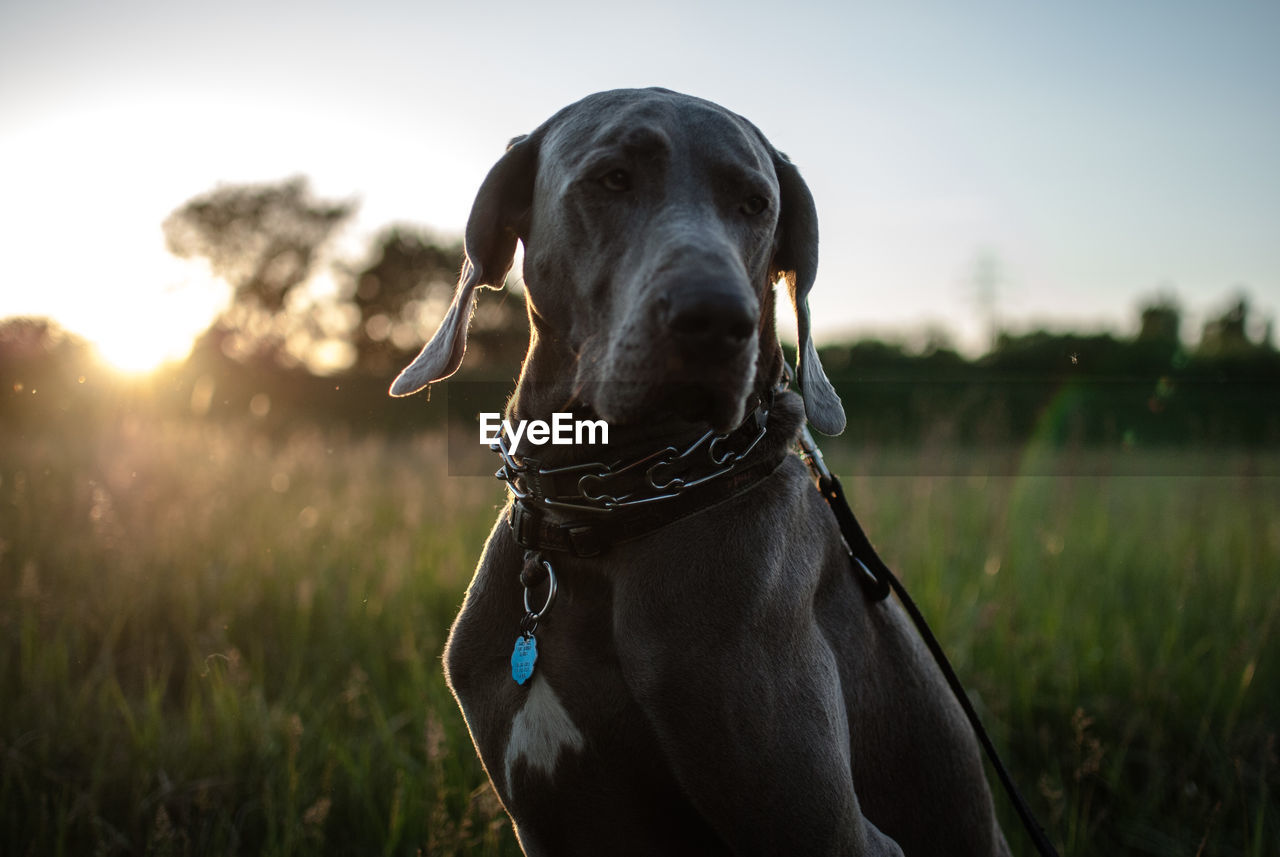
left=392, top=90, right=845, bottom=435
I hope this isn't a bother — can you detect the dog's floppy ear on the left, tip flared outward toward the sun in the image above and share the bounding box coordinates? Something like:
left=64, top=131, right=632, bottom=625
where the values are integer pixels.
left=390, top=137, right=538, bottom=397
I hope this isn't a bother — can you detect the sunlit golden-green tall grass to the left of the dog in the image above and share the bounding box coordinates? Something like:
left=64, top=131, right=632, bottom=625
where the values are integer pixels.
left=0, top=421, right=515, bottom=854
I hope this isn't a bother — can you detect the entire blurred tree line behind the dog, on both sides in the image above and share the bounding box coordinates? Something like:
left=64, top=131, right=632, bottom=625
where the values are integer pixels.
left=0, top=172, right=1280, bottom=445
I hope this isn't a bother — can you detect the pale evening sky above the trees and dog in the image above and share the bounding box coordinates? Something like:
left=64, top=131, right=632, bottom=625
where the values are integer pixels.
left=0, top=0, right=1280, bottom=368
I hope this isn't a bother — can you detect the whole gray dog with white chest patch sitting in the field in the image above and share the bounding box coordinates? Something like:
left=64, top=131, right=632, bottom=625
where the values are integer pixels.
left=392, top=90, right=1009, bottom=856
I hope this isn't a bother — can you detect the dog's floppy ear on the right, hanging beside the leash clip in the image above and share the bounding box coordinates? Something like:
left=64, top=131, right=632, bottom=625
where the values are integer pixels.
left=769, top=150, right=845, bottom=435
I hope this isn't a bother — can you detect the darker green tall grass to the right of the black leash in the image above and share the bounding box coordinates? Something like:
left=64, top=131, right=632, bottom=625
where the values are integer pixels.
left=836, top=450, right=1280, bottom=856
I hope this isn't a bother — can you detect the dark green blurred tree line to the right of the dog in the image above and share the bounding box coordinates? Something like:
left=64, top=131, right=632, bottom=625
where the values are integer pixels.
left=822, top=295, right=1280, bottom=446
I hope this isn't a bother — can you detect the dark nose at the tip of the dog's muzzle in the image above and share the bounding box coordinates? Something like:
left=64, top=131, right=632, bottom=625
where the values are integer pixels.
left=663, top=288, right=760, bottom=358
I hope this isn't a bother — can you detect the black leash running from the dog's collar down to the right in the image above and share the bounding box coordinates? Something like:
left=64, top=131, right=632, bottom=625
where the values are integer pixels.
left=800, top=426, right=1057, bottom=857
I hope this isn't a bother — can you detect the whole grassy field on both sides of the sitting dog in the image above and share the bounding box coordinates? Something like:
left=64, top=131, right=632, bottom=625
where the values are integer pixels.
left=0, top=420, right=1280, bottom=857
